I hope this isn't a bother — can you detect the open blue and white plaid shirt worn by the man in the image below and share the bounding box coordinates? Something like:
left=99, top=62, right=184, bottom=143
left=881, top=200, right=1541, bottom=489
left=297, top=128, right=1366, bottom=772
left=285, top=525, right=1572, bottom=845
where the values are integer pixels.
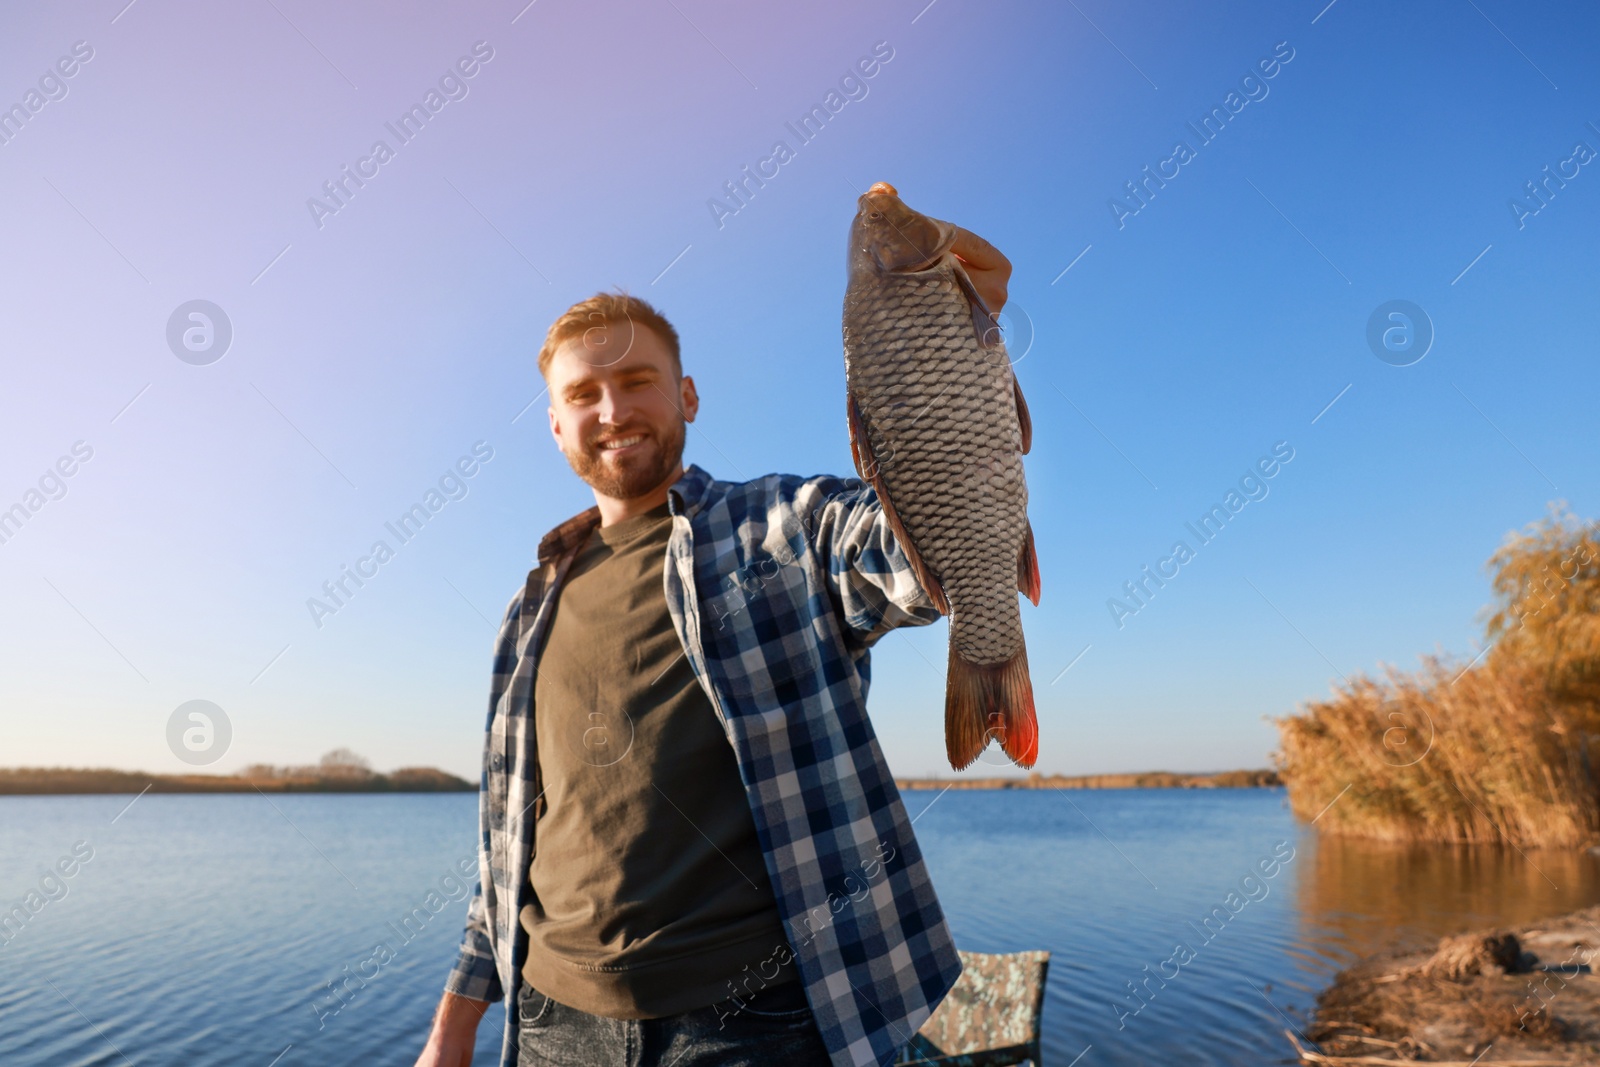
left=446, top=466, right=962, bottom=1067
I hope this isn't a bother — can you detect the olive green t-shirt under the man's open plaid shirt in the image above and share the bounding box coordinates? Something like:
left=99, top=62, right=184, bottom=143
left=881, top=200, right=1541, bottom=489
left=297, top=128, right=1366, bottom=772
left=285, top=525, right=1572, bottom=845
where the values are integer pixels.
left=520, top=504, right=795, bottom=1019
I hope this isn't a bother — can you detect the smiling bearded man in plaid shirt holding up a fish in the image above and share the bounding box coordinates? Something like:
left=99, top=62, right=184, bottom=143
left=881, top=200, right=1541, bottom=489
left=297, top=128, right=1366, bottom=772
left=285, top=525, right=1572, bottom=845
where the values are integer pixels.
left=418, top=220, right=1011, bottom=1067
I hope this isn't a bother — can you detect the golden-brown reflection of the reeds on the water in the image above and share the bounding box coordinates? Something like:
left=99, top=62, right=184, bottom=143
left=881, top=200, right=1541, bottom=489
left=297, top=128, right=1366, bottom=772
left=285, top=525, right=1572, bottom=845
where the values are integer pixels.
left=1296, top=833, right=1600, bottom=971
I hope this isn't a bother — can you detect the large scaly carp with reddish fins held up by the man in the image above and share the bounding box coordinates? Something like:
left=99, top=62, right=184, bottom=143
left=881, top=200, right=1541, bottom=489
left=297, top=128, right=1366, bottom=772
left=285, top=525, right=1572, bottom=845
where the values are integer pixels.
left=845, top=182, right=1038, bottom=769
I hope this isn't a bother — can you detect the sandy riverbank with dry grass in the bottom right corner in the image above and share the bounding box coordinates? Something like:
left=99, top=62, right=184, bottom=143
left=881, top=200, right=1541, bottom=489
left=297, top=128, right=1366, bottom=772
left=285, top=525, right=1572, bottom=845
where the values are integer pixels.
left=1288, top=907, right=1600, bottom=1067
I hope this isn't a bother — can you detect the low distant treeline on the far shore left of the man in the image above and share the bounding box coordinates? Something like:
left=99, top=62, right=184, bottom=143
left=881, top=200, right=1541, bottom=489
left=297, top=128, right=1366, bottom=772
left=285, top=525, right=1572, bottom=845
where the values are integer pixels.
left=0, top=749, right=477, bottom=797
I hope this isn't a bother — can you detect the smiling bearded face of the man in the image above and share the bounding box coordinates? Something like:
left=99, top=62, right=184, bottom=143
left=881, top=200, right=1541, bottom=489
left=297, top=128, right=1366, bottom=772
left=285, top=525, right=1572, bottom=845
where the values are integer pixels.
left=547, top=322, right=699, bottom=501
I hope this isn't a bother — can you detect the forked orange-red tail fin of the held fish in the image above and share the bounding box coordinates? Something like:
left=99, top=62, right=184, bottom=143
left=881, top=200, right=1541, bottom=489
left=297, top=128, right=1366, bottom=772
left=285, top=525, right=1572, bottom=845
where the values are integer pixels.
left=944, top=645, right=1038, bottom=771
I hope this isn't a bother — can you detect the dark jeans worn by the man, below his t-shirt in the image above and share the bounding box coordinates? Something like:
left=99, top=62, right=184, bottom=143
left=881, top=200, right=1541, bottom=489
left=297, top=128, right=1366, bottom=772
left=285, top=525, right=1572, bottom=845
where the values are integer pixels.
left=517, top=981, right=829, bottom=1067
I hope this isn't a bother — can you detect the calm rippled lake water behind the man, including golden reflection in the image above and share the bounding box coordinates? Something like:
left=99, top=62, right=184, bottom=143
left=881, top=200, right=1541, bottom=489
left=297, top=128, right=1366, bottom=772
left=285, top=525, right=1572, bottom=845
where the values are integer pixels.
left=0, top=790, right=1600, bottom=1067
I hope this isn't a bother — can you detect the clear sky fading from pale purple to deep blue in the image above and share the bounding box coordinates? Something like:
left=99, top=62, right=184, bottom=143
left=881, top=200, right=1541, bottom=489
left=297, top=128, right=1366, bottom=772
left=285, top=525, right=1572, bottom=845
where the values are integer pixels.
left=0, top=0, right=1600, bottom=777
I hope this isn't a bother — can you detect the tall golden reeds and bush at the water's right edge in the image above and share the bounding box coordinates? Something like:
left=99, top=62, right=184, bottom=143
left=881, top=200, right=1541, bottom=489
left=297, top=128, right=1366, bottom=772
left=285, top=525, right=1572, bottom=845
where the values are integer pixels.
left=1277, top=504, right=1600, bottom=848
